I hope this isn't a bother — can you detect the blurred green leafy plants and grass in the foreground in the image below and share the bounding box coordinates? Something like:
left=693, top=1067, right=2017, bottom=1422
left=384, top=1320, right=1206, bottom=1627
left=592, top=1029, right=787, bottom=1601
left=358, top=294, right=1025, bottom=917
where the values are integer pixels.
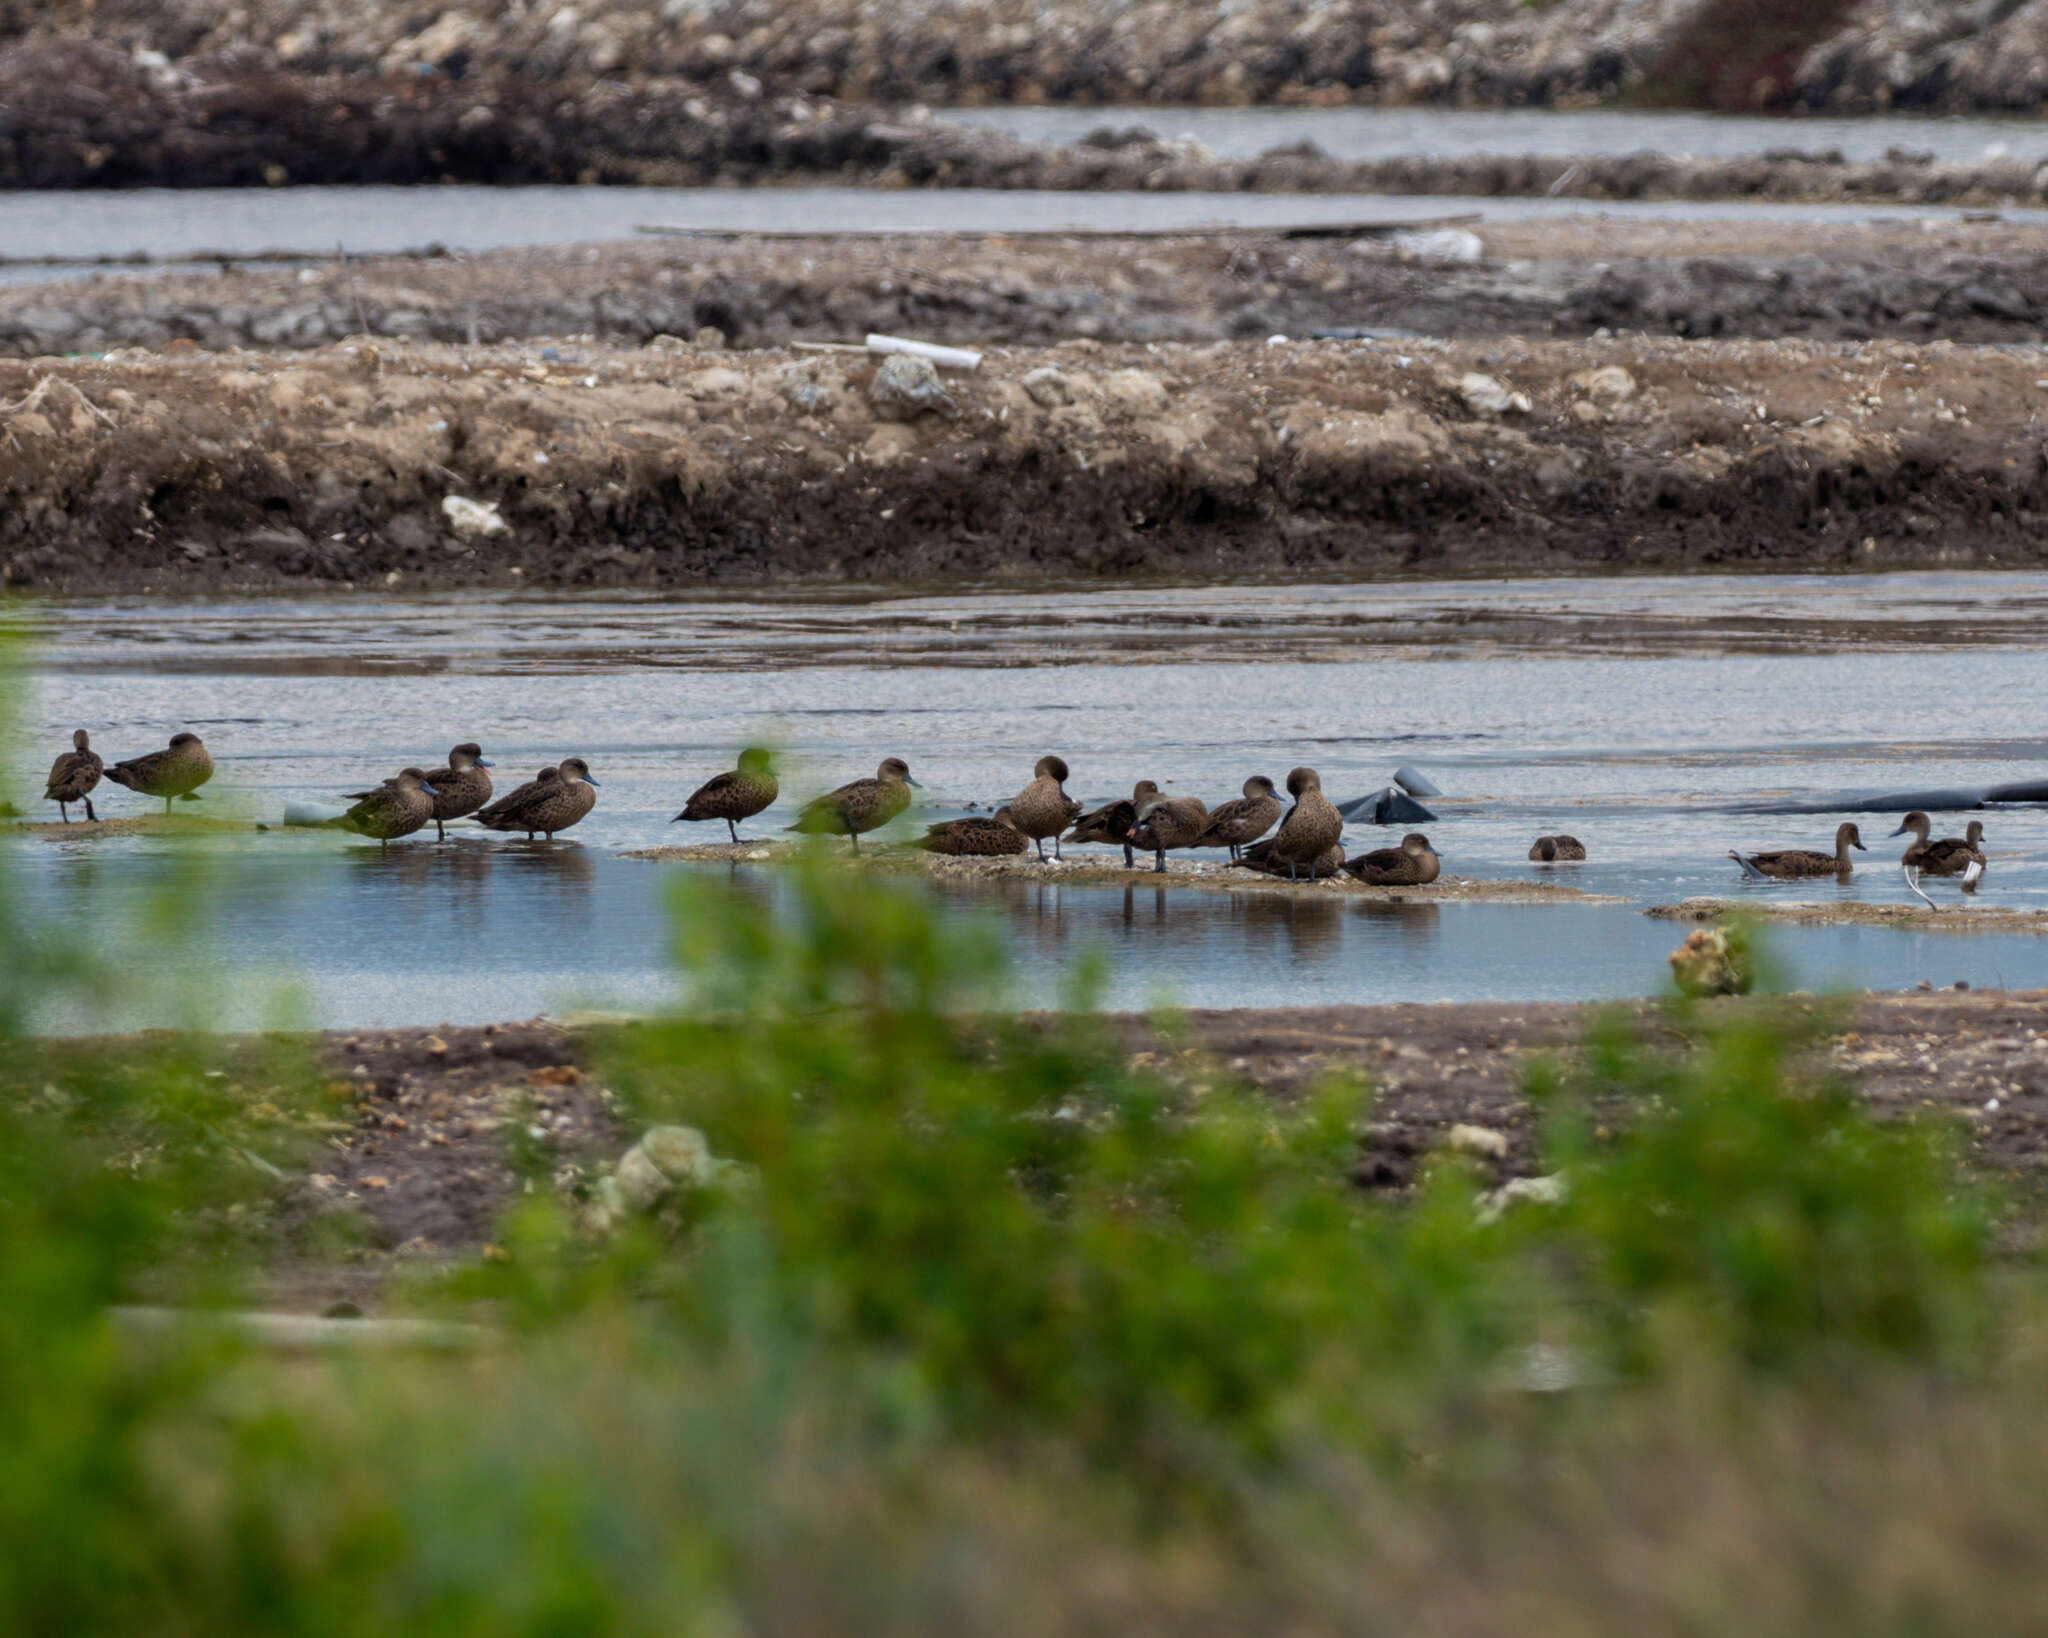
left=0, top=831, right=2048, bottom=1638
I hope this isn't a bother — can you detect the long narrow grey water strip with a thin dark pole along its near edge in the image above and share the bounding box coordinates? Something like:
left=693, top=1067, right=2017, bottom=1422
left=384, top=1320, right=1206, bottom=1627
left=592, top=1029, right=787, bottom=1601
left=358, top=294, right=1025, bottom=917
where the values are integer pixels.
left=0, top=186, right=2048, bottom=283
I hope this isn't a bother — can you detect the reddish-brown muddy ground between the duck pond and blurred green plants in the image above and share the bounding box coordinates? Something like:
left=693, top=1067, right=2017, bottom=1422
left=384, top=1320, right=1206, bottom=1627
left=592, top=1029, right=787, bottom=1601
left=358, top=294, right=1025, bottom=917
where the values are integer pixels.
left=148, top=991, right=2048, bottom=1302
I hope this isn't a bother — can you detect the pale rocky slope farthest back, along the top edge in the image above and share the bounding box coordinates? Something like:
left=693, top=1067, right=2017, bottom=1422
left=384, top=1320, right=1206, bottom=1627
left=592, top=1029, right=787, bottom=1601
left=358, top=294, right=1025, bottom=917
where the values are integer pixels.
left=12, top=0, right=2048, bottom=111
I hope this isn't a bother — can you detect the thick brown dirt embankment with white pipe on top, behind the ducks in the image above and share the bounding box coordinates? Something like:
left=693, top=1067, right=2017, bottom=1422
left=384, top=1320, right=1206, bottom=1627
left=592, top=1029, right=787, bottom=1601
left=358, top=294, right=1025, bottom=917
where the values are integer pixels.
left=0, top=329, right=2048, bottom=594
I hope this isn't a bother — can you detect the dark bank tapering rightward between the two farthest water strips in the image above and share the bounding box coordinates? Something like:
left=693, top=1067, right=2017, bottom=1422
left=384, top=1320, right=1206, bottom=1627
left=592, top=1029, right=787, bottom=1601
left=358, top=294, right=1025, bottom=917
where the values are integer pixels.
left=16, top=39, right=2048, bottom=207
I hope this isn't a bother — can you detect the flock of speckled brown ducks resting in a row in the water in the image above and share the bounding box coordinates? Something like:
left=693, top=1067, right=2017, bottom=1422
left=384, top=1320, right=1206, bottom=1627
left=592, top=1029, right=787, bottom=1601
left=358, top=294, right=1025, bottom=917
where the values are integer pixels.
left=43, top=729, right=1985, bottom=905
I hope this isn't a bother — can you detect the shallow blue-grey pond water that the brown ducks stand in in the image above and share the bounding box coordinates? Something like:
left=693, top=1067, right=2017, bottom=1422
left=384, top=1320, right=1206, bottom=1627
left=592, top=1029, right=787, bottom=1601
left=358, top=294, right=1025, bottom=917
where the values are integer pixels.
left=6, top=573, right=2048, bottom=1024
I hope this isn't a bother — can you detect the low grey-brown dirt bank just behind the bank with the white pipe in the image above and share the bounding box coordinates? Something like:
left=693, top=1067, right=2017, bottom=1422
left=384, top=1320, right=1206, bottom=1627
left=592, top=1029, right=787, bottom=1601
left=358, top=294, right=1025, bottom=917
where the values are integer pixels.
left=12, top=221, right=2048, bottom=358
